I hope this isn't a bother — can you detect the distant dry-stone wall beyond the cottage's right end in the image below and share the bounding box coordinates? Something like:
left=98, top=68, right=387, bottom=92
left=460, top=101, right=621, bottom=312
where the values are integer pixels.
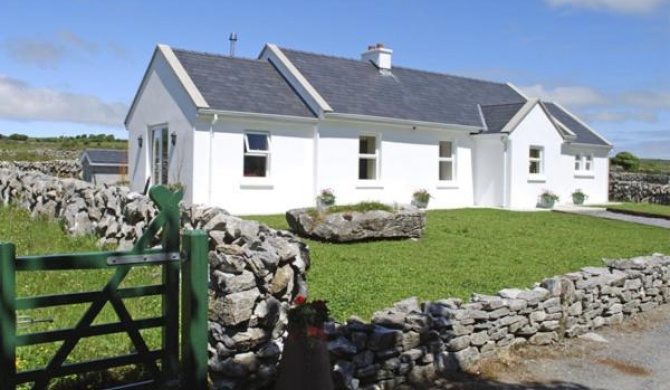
left=609, top=172, right=670, bottom=205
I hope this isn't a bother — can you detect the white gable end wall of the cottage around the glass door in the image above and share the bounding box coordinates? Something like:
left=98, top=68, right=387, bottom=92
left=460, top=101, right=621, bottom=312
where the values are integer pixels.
left=126, top=52, right=196, bottom=203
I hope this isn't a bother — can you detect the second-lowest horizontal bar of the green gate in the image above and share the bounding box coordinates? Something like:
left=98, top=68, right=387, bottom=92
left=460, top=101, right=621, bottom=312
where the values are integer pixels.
left=16, top=317, right=165, bottom=347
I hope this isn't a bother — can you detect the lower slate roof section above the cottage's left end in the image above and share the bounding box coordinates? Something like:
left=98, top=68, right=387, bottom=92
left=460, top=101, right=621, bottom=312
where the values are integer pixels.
left=173, top=49, right=314, bottom=117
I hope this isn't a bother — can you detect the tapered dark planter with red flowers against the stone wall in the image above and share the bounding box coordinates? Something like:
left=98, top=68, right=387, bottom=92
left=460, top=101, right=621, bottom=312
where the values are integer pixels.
left=275, top=295, right=333, bottom=390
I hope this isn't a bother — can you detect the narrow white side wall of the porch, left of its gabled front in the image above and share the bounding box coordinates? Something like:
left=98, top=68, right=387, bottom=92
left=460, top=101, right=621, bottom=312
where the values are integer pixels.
left=474, top=134, right=506, bottom=207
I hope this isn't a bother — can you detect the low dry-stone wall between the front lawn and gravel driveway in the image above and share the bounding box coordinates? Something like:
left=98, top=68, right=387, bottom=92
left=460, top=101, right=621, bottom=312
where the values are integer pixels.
left=318, top=254, right=670, bottom=389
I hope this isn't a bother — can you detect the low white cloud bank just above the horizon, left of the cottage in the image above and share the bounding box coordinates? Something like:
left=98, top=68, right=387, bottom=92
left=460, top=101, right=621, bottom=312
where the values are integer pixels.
left=0, top=75, right=128, bottom=126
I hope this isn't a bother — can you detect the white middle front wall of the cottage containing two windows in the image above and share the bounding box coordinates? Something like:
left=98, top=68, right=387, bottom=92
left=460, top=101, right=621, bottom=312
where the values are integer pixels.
left=316, top=120, right=473, bottom=208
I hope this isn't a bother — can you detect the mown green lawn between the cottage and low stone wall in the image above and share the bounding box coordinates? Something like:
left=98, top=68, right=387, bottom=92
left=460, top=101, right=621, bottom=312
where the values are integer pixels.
left=245, top=209, right=670, bottom=320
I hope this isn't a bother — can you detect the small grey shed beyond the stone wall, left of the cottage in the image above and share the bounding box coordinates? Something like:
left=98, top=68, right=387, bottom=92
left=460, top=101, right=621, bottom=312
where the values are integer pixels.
left=79, top=149, right=128, bottom=184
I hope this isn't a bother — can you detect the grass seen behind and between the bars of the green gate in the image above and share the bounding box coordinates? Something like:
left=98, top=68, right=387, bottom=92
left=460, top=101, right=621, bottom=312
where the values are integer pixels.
left=0, top=207, right=160, bottom=387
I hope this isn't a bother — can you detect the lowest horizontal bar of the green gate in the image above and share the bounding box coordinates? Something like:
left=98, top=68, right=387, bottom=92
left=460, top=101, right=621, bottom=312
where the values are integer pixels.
left=17, top=351, right=161, bottom=388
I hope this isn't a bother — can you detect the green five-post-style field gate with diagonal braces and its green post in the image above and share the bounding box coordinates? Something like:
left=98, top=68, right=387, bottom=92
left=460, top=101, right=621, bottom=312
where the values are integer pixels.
left=0, top=186, right=208, bottom=390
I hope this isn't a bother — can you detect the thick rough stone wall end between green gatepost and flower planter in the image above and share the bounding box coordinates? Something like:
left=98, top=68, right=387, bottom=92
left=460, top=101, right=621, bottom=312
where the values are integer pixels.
left=183, top=207, right=310, bottom=389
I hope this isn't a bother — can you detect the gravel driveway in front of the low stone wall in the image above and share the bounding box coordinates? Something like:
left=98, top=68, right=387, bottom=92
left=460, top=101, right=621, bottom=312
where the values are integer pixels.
left=418, top=304, right=670, bottom=390
